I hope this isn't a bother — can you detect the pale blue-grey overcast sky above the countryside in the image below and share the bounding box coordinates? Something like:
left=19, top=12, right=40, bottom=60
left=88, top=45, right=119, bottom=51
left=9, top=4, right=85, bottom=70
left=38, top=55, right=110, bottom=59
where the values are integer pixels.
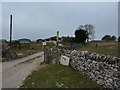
left=2, top=2, right=118, bottom=40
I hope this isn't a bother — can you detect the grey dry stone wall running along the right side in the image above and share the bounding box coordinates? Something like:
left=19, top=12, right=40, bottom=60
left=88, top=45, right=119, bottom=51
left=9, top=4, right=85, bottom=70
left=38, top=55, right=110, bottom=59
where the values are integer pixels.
left=60, top=49, right=120, bottom=90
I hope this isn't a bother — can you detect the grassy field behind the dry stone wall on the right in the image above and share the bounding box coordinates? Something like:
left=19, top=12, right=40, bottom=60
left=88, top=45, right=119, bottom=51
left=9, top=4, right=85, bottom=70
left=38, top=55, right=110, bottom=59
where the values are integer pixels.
left=77, top=41, right=120, bottom=57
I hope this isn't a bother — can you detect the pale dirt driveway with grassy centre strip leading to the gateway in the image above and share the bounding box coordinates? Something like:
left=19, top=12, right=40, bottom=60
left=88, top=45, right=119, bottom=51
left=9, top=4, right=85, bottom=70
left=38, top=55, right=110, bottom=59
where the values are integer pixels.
left=2, top=52, right=44, bottom=88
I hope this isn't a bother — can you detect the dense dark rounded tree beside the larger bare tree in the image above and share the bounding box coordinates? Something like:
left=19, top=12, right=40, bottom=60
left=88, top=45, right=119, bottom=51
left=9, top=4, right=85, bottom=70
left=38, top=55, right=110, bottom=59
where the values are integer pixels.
left=75, top=29, right=88, bottom=43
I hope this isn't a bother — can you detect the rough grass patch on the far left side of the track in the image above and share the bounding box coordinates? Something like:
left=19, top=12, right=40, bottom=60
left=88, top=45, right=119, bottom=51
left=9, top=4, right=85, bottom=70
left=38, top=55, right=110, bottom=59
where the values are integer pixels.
left=2, top=44, right=42, bottom=62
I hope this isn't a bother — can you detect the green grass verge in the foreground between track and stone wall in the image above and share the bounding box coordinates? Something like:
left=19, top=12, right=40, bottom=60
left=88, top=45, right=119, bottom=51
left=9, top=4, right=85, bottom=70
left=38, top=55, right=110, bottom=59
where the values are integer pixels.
left=20, top=65, right=103, bottom=88
